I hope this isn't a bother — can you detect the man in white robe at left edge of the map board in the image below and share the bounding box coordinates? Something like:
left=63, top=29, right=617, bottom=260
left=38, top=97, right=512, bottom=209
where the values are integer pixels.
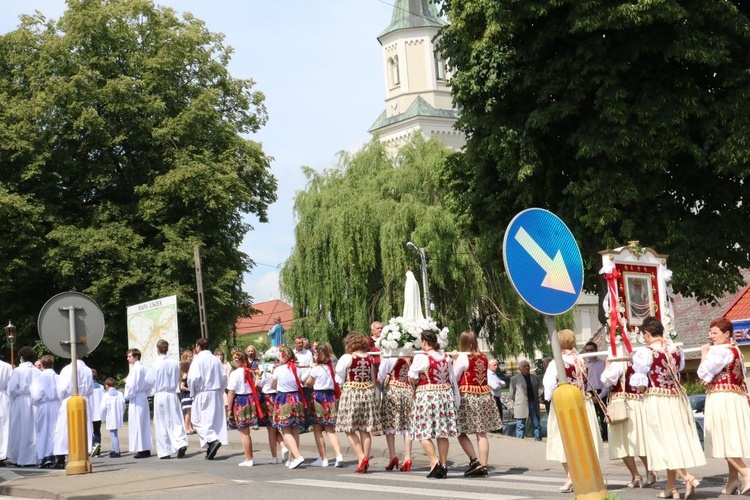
left=125, top=349, right=151, bottom=458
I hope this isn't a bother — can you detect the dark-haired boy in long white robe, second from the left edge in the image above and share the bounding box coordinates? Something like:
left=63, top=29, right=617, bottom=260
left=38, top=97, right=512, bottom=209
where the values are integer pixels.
left=8, top=346, right=41, bottom=466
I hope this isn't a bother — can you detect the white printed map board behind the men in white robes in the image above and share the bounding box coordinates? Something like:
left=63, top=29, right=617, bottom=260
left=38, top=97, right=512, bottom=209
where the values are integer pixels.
left=128, top=295, right=180, bottom=366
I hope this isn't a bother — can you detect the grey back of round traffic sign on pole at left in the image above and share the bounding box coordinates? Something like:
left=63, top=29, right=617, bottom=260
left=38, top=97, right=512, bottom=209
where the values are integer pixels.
left=37, top=292, right=104, bottom=358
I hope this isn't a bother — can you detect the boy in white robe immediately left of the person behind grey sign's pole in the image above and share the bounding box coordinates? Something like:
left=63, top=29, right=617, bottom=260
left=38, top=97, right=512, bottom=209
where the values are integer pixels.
left=30, top=355, right=60, bottom=469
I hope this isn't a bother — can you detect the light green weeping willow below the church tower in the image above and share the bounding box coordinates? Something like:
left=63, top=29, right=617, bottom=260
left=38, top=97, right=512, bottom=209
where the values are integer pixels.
left=281, top=134, right=546, bottom=354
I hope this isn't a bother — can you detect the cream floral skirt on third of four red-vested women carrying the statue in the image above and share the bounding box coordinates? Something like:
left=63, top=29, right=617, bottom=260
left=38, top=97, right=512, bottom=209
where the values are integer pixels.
left=410, top=385, right=458, bottom=441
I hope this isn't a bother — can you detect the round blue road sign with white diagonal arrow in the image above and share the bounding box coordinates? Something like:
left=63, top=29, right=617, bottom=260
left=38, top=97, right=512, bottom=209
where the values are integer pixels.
left=503, top=208, right=583, bottom=316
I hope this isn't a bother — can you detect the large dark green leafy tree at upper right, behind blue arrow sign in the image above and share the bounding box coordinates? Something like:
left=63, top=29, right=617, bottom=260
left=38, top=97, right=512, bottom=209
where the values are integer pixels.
left=439, top=0, right=750, bottom=300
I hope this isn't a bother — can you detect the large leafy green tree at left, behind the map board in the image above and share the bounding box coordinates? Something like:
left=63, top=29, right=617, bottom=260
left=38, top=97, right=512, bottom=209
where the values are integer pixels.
left=0, top=0, right=276, bottom=373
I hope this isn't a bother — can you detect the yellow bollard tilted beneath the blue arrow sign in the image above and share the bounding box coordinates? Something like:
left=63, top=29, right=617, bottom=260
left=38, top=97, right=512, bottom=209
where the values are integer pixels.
left=552, top=384, right=607, bottom=500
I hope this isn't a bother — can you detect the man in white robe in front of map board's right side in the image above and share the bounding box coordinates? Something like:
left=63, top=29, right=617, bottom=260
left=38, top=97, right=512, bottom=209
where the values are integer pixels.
left=147, top=339, right=188, bottom=459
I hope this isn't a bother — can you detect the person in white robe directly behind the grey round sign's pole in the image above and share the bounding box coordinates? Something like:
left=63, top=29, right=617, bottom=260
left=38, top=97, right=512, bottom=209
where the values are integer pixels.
left=53, top=359, right=94, bottom=469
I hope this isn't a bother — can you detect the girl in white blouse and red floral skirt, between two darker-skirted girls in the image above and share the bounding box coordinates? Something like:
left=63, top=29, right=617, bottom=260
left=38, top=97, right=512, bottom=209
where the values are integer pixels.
left=271, top=346, right=307, bottom=469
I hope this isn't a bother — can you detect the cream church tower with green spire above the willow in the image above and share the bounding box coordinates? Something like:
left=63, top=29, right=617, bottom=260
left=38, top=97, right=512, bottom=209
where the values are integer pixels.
left=369, top=0, right=465, bottom=151
